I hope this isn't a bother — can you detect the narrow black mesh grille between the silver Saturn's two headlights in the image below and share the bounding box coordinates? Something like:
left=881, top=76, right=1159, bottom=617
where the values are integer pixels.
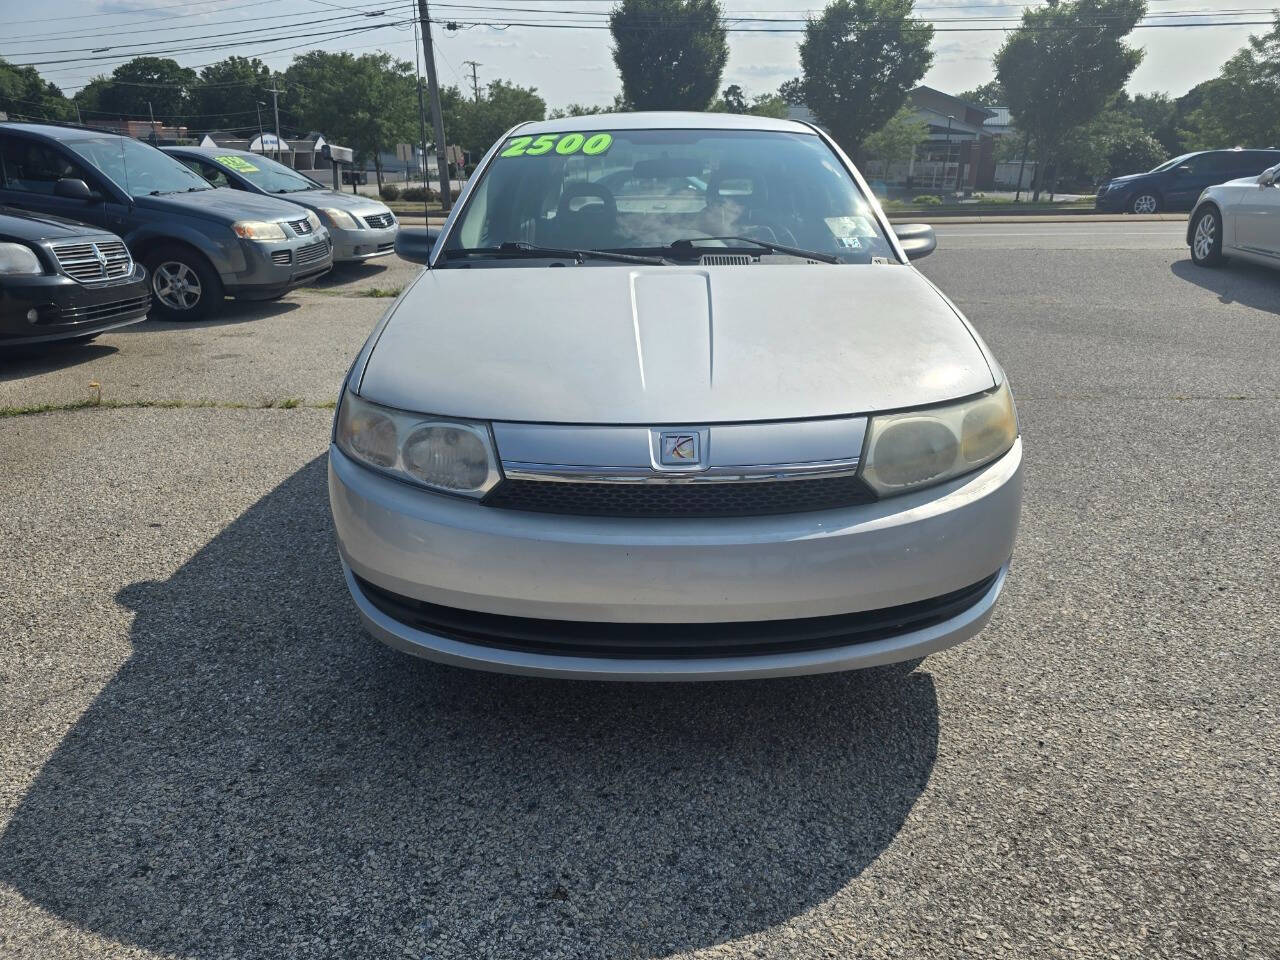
left=481, top=476, right=876, bottom=517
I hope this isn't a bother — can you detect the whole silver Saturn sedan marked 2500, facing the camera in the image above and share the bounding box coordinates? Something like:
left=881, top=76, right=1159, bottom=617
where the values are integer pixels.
left=329, top=114, right=1021, bottom=680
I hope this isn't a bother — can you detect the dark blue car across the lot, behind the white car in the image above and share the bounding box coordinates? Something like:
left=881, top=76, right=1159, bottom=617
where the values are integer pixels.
left=1093, top=147, right=1280, bottom=214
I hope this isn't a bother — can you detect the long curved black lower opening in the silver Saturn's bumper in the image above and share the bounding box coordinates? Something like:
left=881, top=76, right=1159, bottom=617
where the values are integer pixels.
left=356, top=571, right=1000, bottom=659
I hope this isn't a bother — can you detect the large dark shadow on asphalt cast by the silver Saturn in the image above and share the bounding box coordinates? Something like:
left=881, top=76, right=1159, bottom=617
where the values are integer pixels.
left=0, top=457, right=938, bottom=960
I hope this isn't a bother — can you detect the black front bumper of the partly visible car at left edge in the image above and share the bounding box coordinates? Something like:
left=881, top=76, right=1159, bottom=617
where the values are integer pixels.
left=0, top=264, right=151, bottom=346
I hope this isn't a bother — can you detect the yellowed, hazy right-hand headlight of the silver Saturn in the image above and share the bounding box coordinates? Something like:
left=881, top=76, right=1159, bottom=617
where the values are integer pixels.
left=863, top=383, right=1018, bottom=497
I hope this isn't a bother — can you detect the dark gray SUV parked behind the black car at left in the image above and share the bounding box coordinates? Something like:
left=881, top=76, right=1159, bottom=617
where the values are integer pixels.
left=0, top=123, right=333, bottom=320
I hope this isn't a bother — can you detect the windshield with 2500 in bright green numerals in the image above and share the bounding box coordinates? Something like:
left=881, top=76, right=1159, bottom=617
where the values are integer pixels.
left=444, top=129, right=893, bottom=264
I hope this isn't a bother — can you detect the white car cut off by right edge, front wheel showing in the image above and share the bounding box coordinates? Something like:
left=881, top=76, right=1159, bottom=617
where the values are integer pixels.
left=1187, top=165, right=1280, bottom=266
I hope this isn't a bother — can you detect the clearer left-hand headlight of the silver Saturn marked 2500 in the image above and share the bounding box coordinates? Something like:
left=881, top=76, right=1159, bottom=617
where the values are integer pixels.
left=334, top=390, right=502, bottom=498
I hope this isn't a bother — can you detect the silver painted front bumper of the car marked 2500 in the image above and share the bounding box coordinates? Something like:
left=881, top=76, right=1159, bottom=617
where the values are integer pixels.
left=329, top=440, right=1021, bottom=680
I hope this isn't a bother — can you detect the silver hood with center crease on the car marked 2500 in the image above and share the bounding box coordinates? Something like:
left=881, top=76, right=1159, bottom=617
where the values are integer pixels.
left=360, top=264, right=995, bottom=424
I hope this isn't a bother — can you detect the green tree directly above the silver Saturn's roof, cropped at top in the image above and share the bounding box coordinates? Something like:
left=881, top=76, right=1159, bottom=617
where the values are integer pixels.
left=609, top=0, right=728, bottom=110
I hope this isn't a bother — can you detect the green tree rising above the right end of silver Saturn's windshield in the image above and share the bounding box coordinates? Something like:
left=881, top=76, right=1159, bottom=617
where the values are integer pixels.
left=800, top=0, right=933, bottom=159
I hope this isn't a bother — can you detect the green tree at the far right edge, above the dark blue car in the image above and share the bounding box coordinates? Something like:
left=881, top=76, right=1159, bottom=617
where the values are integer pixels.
left=1184, top=12, right=1280, bottom=150
